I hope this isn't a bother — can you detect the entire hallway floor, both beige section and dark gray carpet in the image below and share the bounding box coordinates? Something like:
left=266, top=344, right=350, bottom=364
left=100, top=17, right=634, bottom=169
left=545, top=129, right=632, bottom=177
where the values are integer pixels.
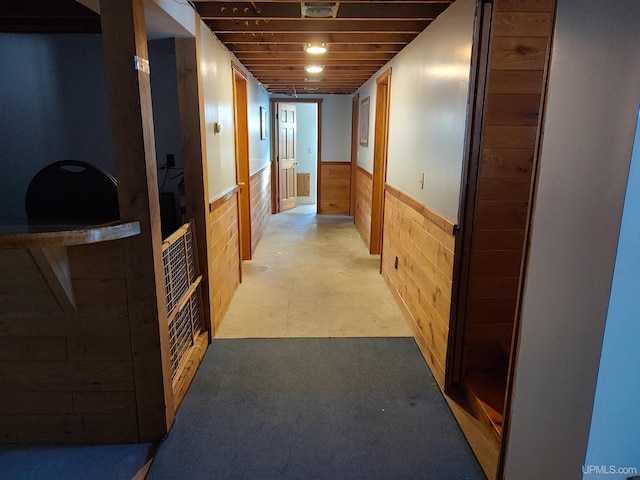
left=146, top=207, right=485, bottom=480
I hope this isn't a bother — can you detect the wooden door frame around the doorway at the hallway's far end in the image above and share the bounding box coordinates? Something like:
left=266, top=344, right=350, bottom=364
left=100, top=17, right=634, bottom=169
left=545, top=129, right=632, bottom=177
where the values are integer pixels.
left=269, top=98, right=323, bottom=213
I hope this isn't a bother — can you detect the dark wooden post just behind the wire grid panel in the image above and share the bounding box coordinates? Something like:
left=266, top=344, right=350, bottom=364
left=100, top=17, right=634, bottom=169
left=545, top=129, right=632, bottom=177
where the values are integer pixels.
left=175, top=32, right=211, bottom=338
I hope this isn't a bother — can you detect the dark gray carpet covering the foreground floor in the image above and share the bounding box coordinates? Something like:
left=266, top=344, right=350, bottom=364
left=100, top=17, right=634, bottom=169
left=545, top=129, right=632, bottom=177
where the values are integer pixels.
left=147, top=338, right=485, bottom=480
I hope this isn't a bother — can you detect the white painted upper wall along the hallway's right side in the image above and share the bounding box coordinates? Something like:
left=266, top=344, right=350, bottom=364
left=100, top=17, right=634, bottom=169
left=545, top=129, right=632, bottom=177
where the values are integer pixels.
left=358, top=0, right=475, bottom=223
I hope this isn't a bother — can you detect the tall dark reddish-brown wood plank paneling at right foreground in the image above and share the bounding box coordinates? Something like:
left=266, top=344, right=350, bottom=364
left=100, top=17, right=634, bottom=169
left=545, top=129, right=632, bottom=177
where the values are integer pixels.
left=452, top=0, right=555, bottom=470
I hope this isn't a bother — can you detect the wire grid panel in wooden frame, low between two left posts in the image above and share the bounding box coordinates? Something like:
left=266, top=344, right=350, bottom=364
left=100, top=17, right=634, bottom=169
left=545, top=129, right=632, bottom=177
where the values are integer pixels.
left=162, top=223, right=202, bottom=381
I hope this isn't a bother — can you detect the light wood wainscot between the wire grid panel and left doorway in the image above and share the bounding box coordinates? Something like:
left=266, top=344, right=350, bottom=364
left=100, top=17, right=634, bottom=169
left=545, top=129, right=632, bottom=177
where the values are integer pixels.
left=209, top=187, right=240, bottom=337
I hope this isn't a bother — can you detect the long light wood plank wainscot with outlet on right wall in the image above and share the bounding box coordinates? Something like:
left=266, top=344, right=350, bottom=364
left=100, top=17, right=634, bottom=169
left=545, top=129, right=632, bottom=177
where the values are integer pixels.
left=382, top=185, right=455, bottom=388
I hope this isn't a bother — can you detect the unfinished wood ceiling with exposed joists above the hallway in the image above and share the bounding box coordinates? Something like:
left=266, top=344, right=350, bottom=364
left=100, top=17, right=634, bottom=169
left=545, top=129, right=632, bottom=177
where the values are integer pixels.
left=192, top=0, right=453, bottom=95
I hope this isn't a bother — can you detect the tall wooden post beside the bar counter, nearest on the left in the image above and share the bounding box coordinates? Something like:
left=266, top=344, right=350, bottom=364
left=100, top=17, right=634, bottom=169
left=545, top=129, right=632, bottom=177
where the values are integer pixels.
left=100, top=0, right=175, bottom=442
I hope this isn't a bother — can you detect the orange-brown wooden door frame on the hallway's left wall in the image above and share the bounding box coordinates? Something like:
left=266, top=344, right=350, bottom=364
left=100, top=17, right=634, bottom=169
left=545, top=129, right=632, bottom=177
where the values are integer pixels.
left=231, top=62, right=251, bottom=260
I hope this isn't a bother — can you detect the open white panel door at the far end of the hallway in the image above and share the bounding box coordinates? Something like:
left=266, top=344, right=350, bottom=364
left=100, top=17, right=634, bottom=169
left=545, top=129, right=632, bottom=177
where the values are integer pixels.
left=278, top=103, right=298, bottom=212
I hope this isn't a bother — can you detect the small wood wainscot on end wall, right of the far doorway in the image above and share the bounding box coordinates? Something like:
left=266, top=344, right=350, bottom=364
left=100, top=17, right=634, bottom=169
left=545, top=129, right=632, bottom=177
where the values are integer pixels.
left=319, top=162, right=351, bottom=215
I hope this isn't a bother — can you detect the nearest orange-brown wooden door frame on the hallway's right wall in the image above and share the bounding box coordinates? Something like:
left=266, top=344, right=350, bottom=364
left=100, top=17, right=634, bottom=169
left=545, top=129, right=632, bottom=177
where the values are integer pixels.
left=369, top=67, right=391, bottom=255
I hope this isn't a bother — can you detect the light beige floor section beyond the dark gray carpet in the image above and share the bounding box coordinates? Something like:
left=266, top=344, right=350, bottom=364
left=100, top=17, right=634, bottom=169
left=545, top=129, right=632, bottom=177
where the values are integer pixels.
left=216, top=205, right=412, bottom=338
